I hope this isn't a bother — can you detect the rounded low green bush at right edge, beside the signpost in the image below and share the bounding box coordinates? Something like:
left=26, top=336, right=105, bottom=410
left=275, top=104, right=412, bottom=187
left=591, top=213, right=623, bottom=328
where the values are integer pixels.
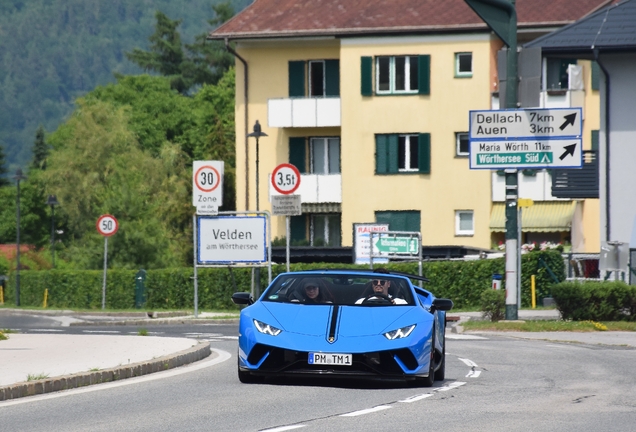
left=552, top=281, right=636, bottom=321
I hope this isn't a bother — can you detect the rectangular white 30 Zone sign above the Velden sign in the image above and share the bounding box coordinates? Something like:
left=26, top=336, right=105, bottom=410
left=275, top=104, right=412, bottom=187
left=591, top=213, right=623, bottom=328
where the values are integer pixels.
left=192, top=161, right=224, bottom=213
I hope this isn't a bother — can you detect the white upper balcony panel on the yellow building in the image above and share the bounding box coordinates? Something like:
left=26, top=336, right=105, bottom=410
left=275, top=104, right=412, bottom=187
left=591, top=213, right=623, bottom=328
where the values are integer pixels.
left=267, top=97, right=342, bottom=128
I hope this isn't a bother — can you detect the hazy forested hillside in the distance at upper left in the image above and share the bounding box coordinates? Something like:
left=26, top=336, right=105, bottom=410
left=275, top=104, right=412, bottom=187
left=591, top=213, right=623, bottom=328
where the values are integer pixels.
left=0, top=0, right=252, bottom=172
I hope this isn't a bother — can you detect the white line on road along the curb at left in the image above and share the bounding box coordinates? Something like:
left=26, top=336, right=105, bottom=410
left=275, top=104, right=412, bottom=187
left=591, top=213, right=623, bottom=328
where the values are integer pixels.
left=0, top=348, right=232, bottom=409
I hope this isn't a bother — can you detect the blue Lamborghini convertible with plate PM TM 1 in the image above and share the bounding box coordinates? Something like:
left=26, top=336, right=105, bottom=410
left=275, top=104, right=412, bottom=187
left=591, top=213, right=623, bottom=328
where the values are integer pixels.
left=232, top=270, right=453, bottom=386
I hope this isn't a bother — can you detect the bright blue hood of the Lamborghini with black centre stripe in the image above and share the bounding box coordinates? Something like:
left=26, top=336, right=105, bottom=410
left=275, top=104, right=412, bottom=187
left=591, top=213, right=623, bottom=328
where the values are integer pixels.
left=262, top=302, right=417, bottom=337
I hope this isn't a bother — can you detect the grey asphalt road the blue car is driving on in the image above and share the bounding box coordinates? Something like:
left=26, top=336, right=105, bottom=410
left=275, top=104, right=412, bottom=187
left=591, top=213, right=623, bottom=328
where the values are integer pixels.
left=0, top=314, right=636, bottom=432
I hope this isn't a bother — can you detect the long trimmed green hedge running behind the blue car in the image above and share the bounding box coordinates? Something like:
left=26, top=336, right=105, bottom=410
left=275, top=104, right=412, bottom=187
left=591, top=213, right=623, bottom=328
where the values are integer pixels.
left=5, top=251, right=565, bottom=310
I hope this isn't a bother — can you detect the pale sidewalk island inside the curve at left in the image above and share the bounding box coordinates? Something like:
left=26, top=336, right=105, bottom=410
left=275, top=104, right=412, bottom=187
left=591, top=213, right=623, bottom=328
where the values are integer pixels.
left=0, top=309, right=216, bottom=401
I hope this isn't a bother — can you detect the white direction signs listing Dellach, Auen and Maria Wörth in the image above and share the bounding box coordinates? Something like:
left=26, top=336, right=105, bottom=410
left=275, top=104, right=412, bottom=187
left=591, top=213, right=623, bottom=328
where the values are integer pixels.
left=469, top=108, right=583, bottom=169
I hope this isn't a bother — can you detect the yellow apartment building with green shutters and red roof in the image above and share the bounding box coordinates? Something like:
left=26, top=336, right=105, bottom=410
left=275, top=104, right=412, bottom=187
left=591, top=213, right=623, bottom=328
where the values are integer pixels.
left=210, top=0, right=606, bottom=251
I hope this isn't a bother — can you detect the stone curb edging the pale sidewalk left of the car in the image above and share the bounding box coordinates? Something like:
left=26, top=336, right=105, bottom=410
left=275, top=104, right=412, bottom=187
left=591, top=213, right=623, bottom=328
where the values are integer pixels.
left=0, top=342, right=216, bottom=401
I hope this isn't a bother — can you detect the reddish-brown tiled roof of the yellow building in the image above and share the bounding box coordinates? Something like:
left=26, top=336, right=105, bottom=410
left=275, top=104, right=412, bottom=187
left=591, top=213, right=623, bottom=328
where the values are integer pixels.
left=210, top=0, right=611, bottom=39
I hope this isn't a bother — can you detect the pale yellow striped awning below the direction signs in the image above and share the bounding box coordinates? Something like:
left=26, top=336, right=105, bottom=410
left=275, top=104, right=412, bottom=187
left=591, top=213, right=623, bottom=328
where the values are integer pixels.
left=490, top=201, right=576, bottom=232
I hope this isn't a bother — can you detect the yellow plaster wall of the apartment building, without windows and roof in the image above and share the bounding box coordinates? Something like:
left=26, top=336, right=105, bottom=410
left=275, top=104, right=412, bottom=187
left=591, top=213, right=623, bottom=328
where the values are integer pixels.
left=236, top=35, right=599, bottom=251
